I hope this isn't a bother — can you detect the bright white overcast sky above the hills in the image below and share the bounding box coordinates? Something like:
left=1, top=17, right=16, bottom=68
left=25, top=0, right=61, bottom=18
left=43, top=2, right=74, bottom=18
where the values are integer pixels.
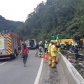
left=0, top=0, right=46, bottom=22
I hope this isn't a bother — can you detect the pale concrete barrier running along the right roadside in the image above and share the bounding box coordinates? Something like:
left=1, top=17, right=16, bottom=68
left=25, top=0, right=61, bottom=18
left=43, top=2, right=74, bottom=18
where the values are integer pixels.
left=59, top=53, right=84, bottom=84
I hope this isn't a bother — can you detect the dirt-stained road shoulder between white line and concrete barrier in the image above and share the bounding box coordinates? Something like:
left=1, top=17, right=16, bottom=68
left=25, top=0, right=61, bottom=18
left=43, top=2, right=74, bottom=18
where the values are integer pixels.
left=39, top=58, right=68, bottom=84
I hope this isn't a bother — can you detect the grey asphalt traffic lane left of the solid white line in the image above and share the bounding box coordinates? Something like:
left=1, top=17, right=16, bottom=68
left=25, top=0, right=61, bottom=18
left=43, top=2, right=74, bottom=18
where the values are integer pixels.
left=0, top=50, right=41, bottom=84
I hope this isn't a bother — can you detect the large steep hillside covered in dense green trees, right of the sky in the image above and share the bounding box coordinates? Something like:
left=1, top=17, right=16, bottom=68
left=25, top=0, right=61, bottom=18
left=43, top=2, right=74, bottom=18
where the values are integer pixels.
left=17, top=0, right=84, bottom=39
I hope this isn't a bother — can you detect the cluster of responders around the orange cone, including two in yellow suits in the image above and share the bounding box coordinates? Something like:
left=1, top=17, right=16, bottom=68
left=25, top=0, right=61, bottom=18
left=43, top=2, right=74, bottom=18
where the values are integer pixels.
left=35, top=40, right=58, bottom=68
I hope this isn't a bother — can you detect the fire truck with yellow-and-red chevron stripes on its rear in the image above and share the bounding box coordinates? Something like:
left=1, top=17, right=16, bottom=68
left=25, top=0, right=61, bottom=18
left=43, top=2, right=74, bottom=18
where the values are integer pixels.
left=0, top=33, right=20, bottom=59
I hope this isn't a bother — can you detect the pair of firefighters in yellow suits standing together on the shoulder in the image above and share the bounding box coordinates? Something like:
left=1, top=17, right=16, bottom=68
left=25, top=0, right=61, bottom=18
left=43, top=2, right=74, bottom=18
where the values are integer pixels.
left=48, top=40, right=58, bottom=68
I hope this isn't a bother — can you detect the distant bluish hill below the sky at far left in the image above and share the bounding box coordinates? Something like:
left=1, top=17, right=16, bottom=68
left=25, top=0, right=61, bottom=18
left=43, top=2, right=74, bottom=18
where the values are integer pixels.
left=0, top=15, right=23, bottom=33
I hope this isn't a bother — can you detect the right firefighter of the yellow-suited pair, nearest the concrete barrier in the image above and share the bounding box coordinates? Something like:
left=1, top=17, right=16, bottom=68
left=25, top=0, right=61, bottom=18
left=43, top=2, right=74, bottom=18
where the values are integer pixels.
left=51, top=41, right=57, bottom=68
